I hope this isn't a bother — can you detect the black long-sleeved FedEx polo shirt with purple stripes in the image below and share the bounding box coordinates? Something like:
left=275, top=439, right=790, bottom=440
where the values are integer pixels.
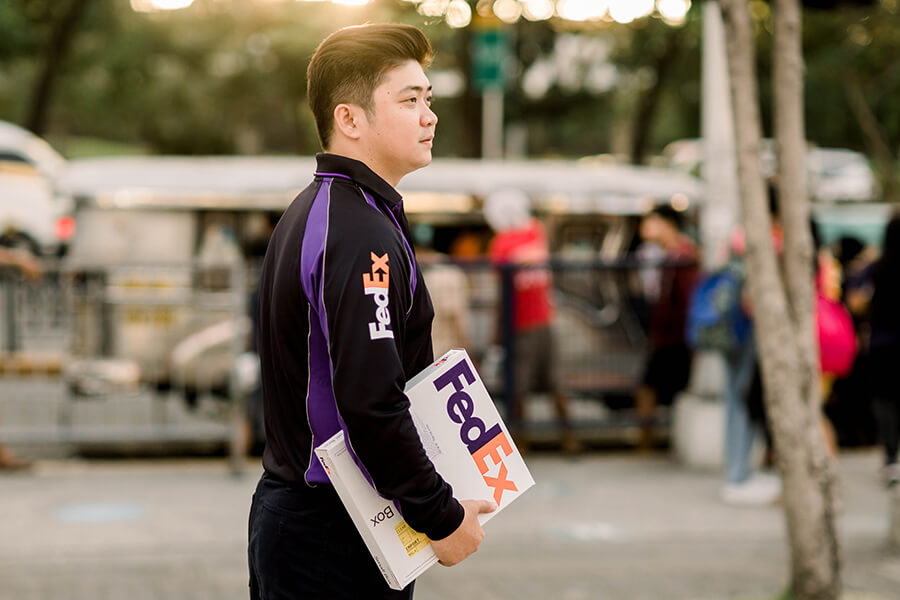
left=258, top=154, right=463, bottom=539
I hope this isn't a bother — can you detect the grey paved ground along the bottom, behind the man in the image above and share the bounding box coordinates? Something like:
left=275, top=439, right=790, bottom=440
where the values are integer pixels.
left=0, top=450, right=900, bottom=600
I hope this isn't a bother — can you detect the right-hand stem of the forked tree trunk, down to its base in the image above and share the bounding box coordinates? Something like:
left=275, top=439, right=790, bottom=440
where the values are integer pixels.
left=772, top=0, right=841, bottom=599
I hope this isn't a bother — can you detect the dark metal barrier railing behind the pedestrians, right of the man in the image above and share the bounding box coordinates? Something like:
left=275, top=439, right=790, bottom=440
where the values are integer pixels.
left=423, top=257, right=695, bottom=442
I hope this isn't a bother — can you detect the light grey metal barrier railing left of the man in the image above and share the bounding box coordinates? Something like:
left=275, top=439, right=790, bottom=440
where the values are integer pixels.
left=0, top=263, right=250, bottom=470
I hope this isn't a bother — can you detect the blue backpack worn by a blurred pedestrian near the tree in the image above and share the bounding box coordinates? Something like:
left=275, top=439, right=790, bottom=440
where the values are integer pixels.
left=685, top=266, right=751, bottom=352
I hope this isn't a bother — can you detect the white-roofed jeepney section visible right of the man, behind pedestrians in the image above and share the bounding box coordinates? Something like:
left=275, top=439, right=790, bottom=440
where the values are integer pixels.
left=399, top=158, right=704, bottom=408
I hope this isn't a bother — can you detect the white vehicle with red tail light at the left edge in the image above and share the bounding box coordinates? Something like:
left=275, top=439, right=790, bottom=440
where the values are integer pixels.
left=0, top=121, right=75, bottom=256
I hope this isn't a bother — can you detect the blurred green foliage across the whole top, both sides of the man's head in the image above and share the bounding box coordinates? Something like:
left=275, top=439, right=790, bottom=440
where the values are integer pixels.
left=0, top=0, right=900, bottom=162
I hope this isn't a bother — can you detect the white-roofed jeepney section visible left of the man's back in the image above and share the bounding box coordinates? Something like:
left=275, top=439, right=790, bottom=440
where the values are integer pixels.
left=59, top=157, right=314, bottom=403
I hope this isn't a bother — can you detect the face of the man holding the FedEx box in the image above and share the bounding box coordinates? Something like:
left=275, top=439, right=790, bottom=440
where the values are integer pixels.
left=360, top=60, right=437, bottom=185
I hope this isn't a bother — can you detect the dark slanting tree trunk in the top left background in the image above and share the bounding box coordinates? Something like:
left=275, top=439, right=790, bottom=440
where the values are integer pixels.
left=25, top=0, right=91, bottom=135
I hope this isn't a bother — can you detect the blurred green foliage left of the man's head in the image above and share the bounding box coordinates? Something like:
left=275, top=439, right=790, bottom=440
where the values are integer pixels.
left=0, top=0, right=422, bottom=154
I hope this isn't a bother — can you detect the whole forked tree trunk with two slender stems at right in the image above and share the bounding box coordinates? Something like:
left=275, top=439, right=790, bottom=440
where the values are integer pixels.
left=719, top=0, right=840, bottom=600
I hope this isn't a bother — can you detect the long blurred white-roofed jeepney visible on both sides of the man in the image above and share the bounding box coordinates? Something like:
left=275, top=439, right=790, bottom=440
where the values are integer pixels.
left=59, top=157, right=702, bottom=414
